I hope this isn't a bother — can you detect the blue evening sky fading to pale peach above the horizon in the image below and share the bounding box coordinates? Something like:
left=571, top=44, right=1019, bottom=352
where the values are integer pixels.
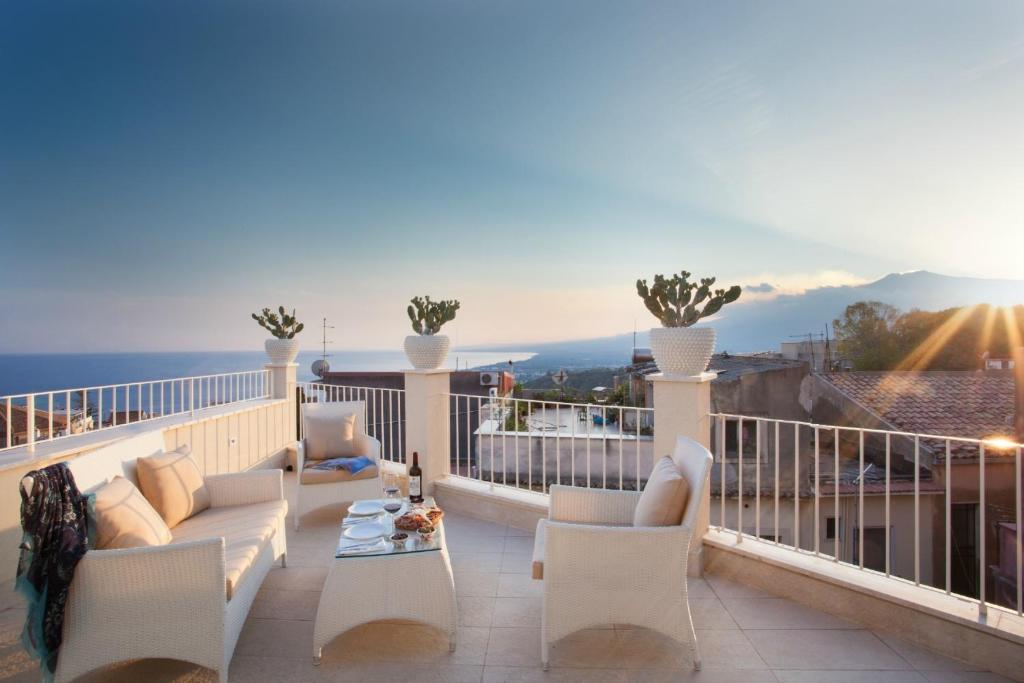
left=0, top=0, right=1024, bottom=352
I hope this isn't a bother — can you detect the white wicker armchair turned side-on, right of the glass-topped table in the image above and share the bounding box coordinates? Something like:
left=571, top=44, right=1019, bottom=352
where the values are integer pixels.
left=534, top=437, right=712, bottom=670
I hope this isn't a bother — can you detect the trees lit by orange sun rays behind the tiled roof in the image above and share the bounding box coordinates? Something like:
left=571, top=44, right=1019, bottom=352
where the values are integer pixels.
left=834, top=301, right=1024, bottom=371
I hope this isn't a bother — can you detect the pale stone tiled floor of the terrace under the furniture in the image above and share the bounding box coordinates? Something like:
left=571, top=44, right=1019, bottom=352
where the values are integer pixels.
left=0, top=475, right=1006, bottom=683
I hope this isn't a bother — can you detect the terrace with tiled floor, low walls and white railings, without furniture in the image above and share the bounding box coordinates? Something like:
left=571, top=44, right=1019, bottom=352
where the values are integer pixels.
left=0, top=368, right=1024, bottom=682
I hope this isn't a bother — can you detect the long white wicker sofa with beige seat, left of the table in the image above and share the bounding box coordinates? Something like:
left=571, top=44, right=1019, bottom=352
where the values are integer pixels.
left=24, top=430, right=288, bottom=683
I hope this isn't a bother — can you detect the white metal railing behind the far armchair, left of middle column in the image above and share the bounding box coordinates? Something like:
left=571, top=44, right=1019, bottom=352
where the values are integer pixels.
left=297, top=382, right=406, bottom=463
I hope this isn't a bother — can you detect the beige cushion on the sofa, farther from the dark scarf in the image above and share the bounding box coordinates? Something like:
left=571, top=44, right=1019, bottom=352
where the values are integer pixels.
left=137, top=446, right=210, bottom=528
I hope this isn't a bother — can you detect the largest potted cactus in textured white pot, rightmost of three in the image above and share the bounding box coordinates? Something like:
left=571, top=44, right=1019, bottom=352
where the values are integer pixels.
left=637, top=270, right=741, bottom=377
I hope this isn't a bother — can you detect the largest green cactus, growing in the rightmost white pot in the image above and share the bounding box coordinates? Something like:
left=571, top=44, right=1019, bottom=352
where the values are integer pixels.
left=637, top=270, right=741, bottom=328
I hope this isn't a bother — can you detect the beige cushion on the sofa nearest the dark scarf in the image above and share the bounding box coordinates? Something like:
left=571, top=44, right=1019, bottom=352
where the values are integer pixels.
left=94, top=477, right=171, bottom=550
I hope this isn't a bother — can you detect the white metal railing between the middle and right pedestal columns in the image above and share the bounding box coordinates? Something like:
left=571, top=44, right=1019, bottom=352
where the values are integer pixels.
left=447, top=393, right=654, bottom=493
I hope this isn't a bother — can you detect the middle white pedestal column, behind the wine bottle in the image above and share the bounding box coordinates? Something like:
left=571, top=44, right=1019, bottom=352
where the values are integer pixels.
left=404, top=369, right=452, bottom=496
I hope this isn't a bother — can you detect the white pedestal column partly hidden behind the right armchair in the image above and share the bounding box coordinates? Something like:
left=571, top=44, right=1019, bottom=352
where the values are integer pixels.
left=647, top=373, right=718, bottom=577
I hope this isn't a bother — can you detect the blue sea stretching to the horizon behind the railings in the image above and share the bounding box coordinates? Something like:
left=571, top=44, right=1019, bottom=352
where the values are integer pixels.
left=0, top=350, right=535, bottom=396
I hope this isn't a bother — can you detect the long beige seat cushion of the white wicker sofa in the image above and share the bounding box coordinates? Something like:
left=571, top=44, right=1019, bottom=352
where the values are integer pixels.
left=171, top=501, right=288, bottom=600
